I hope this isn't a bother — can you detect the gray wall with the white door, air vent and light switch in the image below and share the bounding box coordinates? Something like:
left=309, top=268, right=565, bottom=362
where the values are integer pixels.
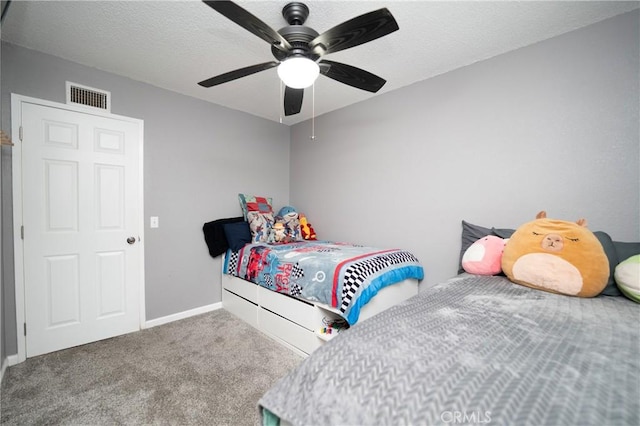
left=2, top=44, right=290, bottom=354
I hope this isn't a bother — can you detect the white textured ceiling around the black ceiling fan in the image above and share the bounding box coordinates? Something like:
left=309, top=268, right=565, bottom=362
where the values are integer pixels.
left=2, top=0, right=640, bottom=125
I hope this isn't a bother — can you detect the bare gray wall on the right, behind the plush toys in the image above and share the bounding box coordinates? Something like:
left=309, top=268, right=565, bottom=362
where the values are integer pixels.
left=291, top=11, right=640, bottom=290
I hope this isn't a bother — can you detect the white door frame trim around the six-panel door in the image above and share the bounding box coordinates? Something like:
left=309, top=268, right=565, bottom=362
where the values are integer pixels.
left=11, top=93, right=146, bottom=363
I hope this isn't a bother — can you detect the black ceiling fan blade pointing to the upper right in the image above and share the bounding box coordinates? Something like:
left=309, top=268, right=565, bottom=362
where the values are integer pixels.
left=309, top=8, right=399, bottom=55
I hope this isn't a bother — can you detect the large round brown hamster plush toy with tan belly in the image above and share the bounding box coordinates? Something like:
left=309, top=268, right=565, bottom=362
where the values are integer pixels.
left=502, top=211, right=609, bottom=297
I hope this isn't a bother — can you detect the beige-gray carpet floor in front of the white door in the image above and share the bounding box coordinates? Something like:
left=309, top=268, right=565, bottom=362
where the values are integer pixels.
left=0, top=309, right=302, bottom=426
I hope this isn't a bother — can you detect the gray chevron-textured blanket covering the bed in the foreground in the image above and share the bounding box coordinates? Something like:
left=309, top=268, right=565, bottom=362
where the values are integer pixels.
left=259, top=274, right=640, bottom=426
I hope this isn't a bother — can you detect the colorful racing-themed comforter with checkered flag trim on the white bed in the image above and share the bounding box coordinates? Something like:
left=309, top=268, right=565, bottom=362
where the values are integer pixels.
left=224, top=241, right=424, bottom=324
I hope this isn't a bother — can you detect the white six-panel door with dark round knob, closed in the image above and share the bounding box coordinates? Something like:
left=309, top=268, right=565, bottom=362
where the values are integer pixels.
left=21, top=102, right=143, bottom=357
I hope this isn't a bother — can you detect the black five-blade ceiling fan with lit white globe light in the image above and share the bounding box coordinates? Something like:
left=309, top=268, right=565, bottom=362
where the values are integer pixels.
left=198, top=0, right=398, bottom=116
